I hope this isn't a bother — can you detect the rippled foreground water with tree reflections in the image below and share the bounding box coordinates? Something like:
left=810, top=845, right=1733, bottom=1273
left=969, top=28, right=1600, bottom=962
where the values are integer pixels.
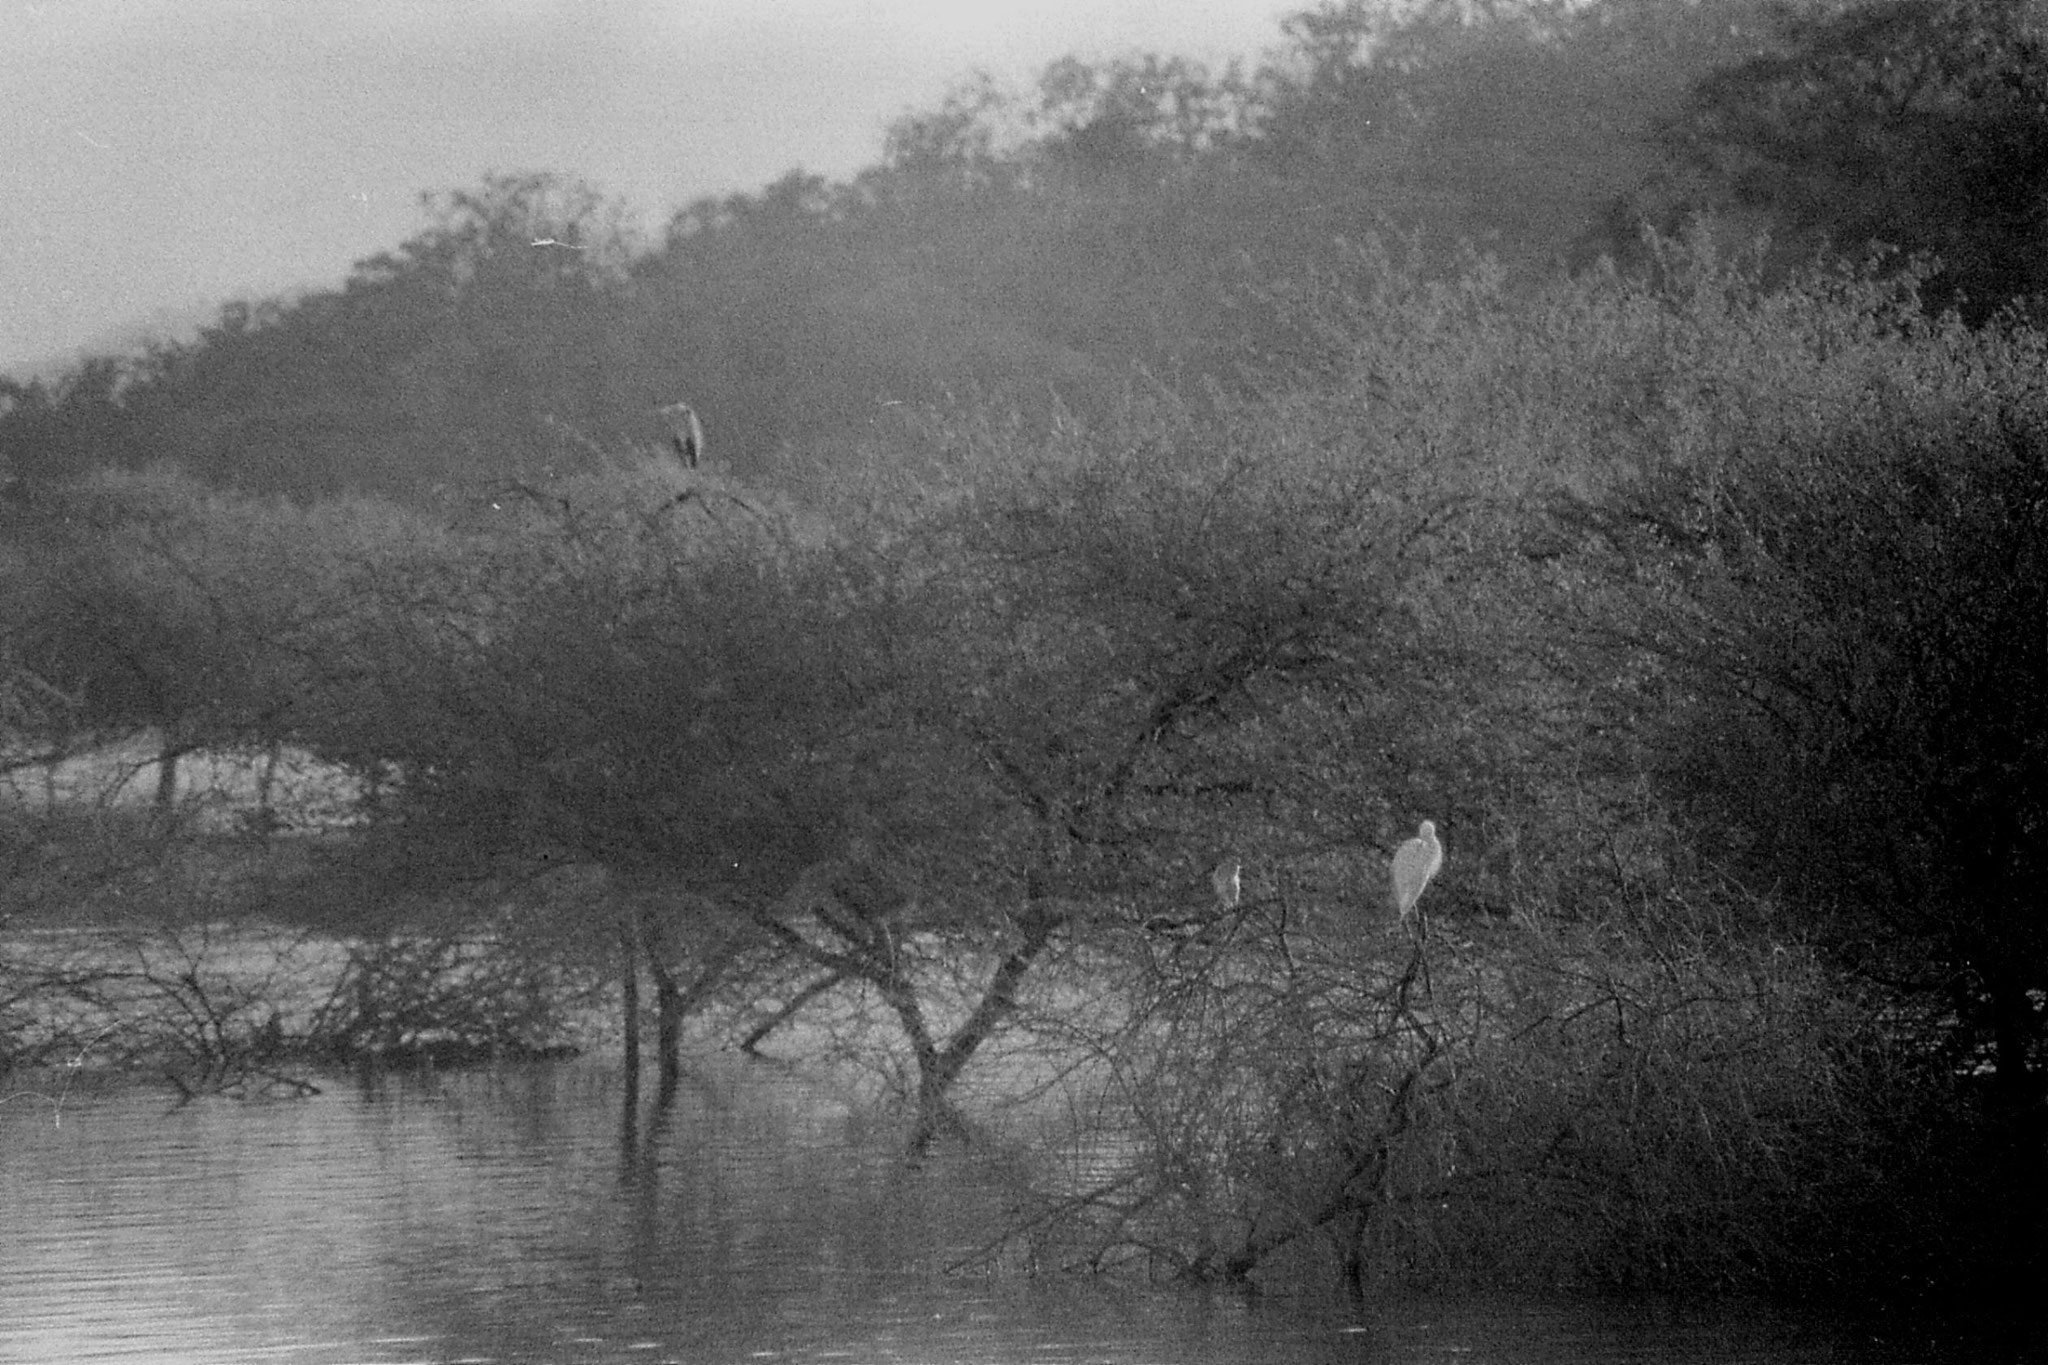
left=0, top=1064, right=2023, bottom=1365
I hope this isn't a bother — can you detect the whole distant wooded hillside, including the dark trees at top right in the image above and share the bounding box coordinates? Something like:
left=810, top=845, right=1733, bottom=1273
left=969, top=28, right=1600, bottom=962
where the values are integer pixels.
left=0, top=0, right=2048, bottom=501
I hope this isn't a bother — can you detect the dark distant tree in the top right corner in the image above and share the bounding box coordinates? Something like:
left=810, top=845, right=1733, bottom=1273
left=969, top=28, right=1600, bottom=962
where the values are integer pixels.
left=1618, top=0, right=2048, bottom=319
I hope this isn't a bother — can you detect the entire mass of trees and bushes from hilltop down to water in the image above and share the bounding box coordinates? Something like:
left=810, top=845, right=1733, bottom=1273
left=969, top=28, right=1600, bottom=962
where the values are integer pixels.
left=0, top=0, right=2048, bottom=1295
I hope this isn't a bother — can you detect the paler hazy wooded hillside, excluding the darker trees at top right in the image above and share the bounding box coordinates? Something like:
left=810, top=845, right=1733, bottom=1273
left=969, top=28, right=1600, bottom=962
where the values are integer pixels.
left=0, top=0, right=1810, bottom=501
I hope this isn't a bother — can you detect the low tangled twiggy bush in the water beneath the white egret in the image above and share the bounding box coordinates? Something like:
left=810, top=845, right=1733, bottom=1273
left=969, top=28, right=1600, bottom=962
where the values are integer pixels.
left=983, top=907, right=1952, bottom=1289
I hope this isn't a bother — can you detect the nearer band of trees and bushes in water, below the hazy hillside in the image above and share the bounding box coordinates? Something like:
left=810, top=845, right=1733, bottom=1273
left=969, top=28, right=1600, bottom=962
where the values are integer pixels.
left=0, top=244, right=2048, bottom=1293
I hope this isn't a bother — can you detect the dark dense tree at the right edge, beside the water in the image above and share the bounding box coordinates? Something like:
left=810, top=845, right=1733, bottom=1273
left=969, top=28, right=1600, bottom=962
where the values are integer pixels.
left=1548, top=258, right=2048, bottom=1285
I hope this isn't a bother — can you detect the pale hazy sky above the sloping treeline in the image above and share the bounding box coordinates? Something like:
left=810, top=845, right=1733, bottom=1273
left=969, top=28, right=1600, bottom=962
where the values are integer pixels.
left=0, top=0, right=1311, bottom=372
